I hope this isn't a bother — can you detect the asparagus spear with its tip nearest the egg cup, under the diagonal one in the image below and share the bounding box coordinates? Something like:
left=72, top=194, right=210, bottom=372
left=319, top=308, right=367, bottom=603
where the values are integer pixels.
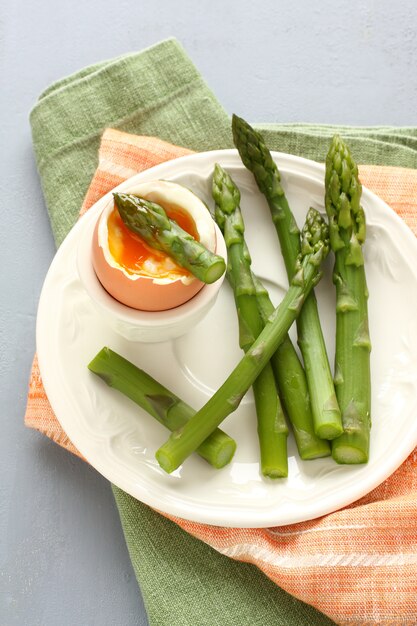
left=212, top=164, right=288, bottom=478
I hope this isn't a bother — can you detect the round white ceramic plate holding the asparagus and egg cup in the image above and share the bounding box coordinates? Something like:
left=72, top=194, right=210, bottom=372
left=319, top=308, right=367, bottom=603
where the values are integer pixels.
left=37, top=150, right=417, bottom=527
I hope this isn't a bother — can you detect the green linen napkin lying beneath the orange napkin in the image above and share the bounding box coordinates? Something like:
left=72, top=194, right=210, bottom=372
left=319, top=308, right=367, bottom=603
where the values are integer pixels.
left=30, top=39, right=417, bottom=626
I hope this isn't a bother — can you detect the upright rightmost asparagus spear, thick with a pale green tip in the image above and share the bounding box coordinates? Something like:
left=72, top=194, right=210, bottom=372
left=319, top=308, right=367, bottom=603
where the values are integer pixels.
left=325, top=135, right=371, bottom=464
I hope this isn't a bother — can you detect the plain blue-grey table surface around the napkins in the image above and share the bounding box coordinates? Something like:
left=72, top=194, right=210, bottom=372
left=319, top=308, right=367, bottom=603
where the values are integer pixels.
left=0, top=0, right=417, bottom=626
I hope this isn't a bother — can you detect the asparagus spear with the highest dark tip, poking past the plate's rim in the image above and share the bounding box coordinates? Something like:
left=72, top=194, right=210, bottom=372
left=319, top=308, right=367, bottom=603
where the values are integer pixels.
left=232, top=115, right=343, bottom=439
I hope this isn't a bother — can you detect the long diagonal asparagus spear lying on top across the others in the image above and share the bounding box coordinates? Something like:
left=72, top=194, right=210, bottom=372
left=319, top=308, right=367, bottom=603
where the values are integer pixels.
left=156, top=209, right=329, bottom=473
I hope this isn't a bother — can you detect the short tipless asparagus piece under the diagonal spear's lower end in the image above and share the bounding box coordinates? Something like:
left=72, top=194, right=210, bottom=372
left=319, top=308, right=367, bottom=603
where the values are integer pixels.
left=88, top=348, right=236, bottom=469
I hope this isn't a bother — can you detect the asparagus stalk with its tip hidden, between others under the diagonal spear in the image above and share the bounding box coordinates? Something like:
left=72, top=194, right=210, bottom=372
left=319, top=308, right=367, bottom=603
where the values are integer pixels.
left=253, top=275, right=330, bottom=460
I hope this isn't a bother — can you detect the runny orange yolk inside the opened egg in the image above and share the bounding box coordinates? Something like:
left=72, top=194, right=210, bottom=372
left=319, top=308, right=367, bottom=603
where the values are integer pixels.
left=107, top=203, right=199, bottom=278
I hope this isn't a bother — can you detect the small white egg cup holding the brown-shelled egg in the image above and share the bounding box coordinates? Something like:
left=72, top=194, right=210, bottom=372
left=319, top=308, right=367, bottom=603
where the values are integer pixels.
left=77, top=204, right=227, bottom=343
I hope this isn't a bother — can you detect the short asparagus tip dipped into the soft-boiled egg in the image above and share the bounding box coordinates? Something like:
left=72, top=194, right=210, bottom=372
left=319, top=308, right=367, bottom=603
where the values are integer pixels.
left=113, top=193, right=226, bottom=283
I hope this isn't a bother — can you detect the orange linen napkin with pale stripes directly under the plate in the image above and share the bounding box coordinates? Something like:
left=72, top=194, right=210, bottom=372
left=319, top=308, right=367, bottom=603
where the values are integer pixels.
left=25, top=129, right=417, bottom=626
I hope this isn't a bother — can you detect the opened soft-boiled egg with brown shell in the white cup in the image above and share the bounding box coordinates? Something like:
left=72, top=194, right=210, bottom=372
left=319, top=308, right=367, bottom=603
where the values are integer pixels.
left=92, top=180, right=216, bottom=311
